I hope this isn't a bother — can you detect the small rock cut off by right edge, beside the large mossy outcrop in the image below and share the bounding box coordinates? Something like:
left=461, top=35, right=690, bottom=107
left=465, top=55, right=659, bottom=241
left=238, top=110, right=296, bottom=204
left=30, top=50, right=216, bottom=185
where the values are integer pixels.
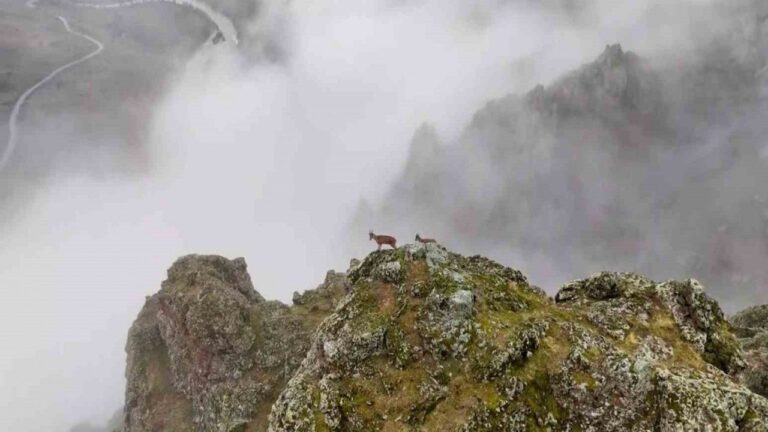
left=730, top=305, right=768, bottom=397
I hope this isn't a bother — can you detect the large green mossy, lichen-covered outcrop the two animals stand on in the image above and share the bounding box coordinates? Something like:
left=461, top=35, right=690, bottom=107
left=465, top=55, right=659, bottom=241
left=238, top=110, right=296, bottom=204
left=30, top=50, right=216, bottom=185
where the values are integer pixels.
left=268, top=245, right=768, bottom=432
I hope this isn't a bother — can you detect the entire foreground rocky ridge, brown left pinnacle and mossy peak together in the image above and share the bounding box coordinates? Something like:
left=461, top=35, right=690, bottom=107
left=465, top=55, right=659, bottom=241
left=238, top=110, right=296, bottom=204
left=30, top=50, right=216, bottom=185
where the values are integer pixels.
left=124, top=244, right=768, bottom=432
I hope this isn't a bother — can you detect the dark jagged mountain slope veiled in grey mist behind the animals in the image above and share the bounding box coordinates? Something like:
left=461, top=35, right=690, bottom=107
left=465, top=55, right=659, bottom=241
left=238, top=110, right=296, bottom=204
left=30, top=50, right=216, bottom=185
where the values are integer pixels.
left=356, top=1, right=768, bottom=310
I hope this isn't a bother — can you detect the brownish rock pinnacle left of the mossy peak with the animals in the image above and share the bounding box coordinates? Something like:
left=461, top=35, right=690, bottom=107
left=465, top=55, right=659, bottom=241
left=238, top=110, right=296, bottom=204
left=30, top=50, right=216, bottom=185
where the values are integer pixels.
left=124, top=255, right=346, bottom=432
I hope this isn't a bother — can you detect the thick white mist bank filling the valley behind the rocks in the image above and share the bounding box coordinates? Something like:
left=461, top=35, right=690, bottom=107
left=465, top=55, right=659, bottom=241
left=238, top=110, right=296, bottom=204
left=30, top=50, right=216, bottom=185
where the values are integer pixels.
left=0, top=0, right=760, bottom=432
